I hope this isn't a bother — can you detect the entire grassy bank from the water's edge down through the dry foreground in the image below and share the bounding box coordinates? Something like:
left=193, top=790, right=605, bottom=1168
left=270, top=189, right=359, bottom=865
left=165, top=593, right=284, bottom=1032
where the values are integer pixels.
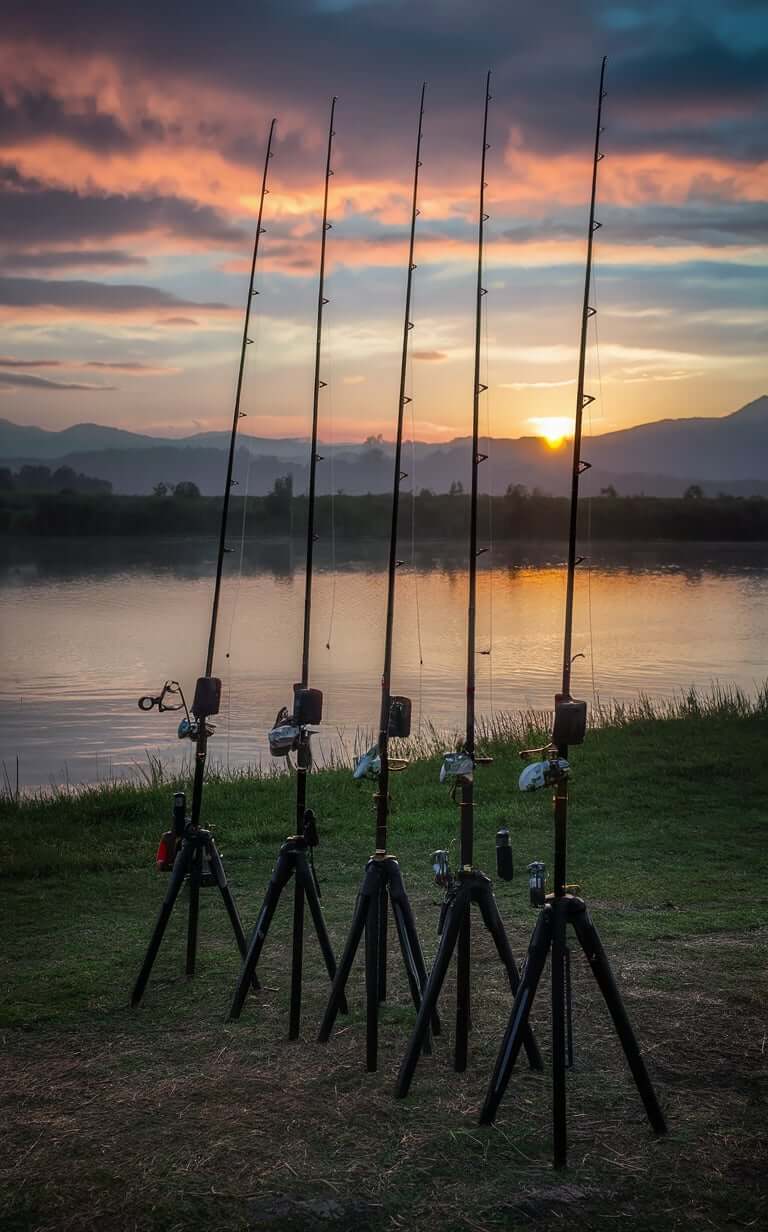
left=0, top=697, right=768, bottom=1232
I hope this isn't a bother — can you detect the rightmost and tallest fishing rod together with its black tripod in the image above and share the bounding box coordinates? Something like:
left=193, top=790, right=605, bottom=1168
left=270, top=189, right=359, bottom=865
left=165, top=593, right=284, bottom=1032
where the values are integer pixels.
left=481, top=57, right=667, bottom=1168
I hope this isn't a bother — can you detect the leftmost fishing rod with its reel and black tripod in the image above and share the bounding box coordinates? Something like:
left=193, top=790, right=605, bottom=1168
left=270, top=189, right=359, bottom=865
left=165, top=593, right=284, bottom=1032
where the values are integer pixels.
left=131, top=120, right=276, bottom=1005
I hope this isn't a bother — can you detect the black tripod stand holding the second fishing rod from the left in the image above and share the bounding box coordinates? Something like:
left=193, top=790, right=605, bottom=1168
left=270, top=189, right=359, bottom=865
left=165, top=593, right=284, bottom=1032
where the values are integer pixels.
left=229, top=728, right=346, bottom=1040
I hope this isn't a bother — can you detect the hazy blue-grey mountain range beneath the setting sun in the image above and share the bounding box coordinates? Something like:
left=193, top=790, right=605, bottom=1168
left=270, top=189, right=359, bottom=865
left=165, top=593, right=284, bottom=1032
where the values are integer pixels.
left=0, top=395, right=768, bottom=496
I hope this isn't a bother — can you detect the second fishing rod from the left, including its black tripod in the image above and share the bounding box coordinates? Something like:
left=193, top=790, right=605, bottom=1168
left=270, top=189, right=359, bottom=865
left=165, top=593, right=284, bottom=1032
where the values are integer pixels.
left=229, top=97, right=346, bottom=1040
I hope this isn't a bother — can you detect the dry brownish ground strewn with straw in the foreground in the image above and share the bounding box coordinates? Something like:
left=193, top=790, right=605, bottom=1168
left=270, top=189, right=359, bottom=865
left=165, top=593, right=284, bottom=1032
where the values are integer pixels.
left=0, top=929, right=768, bottom=1232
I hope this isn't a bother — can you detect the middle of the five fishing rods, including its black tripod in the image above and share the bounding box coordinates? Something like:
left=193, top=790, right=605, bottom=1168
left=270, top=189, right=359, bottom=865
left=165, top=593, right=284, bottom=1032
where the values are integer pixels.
left=318, top=83, right=440, bottom=1072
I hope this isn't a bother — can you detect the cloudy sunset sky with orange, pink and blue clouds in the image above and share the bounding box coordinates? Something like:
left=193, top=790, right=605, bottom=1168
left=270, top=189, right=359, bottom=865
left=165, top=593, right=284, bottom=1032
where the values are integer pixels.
left=0, top=0, right=768, bottom=440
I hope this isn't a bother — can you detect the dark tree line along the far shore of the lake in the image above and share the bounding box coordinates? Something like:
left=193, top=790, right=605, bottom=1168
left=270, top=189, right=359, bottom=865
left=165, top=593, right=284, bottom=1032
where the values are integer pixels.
left=0, top=467, right=768, bottom=541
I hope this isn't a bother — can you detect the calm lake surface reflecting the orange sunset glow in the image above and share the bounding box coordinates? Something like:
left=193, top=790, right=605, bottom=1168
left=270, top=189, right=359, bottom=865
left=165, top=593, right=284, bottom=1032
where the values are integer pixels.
left=0, top=540, right=768, bottom=788
